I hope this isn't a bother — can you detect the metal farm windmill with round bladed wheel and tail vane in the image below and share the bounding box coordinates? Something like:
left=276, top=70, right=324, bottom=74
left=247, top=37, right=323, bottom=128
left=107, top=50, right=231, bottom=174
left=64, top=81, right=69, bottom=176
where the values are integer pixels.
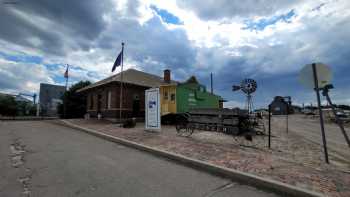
left=232, top=79, right=258, bottom=114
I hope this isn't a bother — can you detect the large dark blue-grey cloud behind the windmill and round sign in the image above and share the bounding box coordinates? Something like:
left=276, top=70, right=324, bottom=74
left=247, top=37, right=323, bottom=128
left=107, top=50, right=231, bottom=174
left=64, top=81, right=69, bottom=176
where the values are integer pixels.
left=193, top=8, right=350, bottom=106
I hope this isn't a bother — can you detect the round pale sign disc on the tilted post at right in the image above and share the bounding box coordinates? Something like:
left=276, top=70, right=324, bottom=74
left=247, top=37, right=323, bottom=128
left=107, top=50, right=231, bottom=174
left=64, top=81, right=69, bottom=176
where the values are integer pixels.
left=299, top=63, right=332, bottom=89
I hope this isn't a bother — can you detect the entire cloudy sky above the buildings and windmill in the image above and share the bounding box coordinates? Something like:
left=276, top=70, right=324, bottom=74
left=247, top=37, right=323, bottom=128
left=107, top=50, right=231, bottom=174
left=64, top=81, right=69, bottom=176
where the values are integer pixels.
left=0, top=0, right=350, bottom=108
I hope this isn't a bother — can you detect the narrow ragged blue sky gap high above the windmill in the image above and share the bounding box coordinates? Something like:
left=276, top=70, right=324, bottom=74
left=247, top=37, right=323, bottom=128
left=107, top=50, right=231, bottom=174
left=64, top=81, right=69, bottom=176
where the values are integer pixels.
left=243, top=10, right=295, bottom=31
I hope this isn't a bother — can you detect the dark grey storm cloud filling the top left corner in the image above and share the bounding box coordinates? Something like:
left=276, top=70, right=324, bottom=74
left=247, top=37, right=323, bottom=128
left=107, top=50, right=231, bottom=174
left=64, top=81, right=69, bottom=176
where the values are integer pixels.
left=0, top=0, right=112, bottom=54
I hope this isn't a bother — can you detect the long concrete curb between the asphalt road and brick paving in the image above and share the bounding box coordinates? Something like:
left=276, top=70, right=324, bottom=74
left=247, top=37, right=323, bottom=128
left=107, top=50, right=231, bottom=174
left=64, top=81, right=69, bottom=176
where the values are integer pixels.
left=52, top=120, right=324, bottom=197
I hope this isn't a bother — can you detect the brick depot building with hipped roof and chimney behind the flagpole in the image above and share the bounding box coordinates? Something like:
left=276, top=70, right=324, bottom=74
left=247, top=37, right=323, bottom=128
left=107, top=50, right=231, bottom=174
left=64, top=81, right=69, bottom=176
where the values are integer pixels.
left=78, top=69, right=177, bottom=119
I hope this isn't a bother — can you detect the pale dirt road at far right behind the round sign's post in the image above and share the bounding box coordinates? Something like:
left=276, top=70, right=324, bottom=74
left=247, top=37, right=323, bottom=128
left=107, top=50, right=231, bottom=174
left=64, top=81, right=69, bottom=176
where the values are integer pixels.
left=273, top=115, right=350, bottom=161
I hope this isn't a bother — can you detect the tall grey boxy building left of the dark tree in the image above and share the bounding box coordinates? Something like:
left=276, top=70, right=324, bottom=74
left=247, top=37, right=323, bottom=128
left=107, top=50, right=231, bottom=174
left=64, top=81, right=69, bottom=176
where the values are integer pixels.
left=39, top=83, right=65, bottom=116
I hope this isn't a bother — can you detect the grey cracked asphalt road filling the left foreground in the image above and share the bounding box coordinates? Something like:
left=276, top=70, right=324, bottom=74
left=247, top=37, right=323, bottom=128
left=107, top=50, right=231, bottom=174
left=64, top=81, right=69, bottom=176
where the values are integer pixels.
left=0, top=121, right=276, bottom=197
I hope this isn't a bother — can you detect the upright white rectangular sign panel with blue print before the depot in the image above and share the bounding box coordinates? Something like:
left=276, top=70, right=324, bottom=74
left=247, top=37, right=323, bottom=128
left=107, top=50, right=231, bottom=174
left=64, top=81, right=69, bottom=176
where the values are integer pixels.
left=145, top=88, right=161, bottom=131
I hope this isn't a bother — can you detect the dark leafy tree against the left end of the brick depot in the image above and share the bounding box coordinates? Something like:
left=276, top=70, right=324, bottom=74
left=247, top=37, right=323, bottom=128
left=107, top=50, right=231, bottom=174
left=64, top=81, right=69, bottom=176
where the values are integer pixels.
left=57, top=81, right=91, bottom=118
